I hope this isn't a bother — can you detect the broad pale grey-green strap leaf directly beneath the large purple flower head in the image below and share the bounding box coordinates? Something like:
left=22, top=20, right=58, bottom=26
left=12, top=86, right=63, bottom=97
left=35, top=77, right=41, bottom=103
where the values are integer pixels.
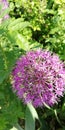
left=25, top=104, right=39, bottom=130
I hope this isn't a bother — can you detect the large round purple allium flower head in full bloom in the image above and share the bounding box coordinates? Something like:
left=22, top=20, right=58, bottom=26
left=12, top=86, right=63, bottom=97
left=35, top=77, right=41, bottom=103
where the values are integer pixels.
left=12, top=50, right=65, bottom=107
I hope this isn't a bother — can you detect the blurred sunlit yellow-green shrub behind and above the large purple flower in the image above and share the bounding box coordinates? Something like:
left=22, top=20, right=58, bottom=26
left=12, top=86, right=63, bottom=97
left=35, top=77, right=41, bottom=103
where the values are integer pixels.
left=10, top=0, right=65, bottom=60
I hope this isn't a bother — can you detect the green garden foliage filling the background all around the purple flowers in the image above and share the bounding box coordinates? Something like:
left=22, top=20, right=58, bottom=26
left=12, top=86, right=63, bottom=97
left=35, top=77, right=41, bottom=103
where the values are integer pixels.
left=0, top=0, right=65, bottom=130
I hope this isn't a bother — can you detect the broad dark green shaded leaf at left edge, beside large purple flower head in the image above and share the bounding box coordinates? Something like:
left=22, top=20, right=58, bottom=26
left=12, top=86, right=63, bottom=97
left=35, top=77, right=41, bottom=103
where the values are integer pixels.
left=0, top=48, right=16, bottom=84
